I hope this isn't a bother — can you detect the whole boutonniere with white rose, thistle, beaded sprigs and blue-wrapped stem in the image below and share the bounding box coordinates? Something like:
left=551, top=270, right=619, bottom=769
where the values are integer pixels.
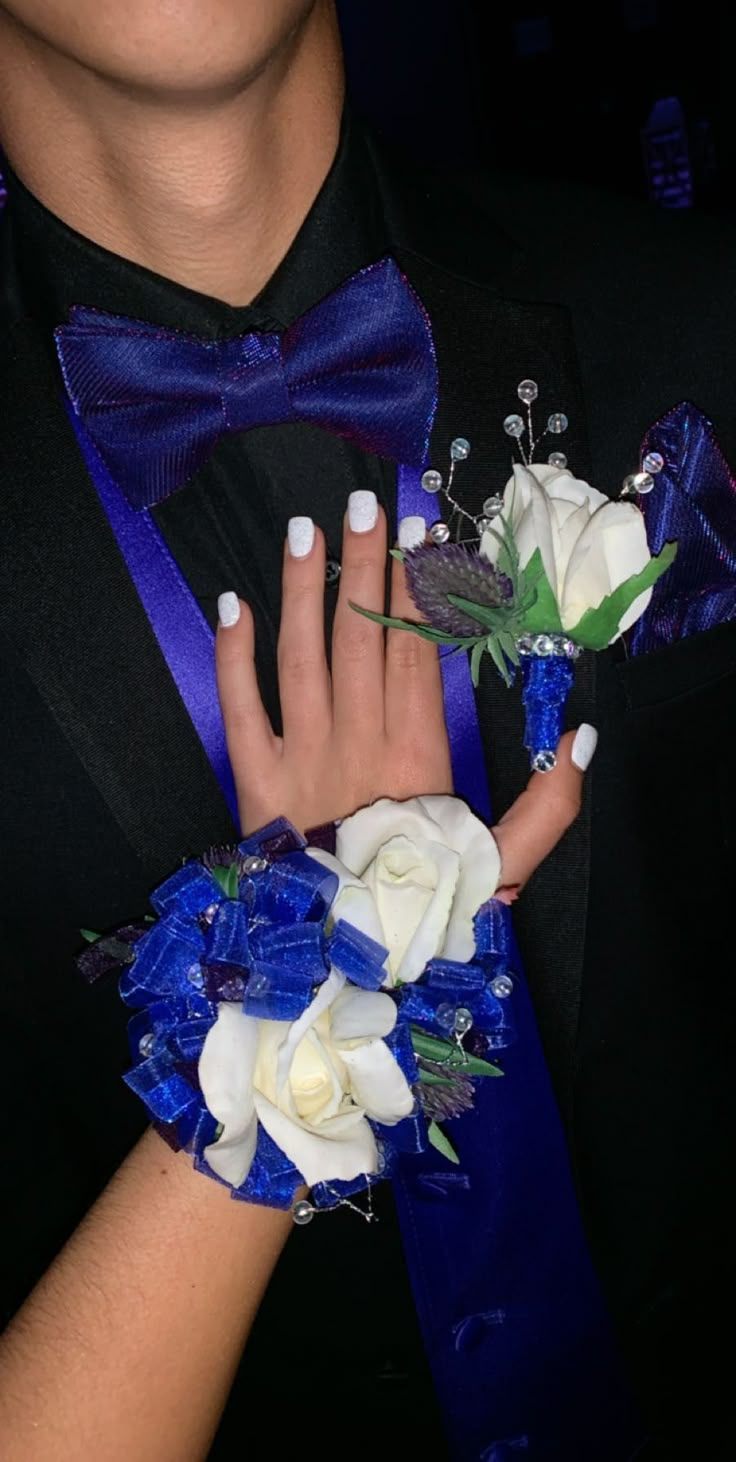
left=354, top=380, right=677, bottom=772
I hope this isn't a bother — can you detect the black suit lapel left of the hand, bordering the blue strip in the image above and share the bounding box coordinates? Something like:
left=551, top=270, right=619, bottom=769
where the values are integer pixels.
left=0, top=322, right=233, bottom=882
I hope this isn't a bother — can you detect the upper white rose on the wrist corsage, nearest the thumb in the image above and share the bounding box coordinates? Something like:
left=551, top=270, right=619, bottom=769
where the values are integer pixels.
left=309, top=795, right=500, bottom=985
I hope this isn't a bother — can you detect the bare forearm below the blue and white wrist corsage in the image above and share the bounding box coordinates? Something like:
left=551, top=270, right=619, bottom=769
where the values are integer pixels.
left=0, top=1132, right=291, bottom=1462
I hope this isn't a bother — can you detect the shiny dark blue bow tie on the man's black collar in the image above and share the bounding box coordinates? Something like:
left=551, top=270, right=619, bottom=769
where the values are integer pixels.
left=56, top=259, right=438, bottom=509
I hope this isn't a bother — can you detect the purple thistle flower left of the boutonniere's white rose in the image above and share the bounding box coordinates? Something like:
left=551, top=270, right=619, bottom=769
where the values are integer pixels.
left=404, top=544, right=514, bottom=639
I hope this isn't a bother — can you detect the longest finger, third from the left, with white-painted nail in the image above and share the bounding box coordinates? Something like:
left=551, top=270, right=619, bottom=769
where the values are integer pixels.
left=332, top=491, right=386, bottom=740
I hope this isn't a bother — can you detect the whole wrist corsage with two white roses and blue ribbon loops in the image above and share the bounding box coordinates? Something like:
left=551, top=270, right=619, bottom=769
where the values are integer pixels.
left=79, top=795, right=514, bottom=1222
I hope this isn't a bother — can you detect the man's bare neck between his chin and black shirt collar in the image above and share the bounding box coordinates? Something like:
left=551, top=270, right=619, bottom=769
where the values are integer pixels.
left=0, top=3, right=342, bottom=306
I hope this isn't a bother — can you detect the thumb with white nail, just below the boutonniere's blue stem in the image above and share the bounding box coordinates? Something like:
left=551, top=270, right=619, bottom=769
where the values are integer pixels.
left=493, top=722, right=598, bottom=902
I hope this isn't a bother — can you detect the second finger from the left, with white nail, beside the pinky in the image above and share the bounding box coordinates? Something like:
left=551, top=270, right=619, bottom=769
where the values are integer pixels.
left=278, top=518, right=332, bottom=747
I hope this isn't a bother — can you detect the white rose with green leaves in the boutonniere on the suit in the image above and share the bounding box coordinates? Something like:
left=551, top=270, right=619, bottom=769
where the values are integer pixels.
left=480, top=463, right=675, bottom=649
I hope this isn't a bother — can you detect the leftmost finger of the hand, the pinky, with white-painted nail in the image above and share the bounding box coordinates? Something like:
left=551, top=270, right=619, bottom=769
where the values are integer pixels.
left=215, top=592, right=278, bottom=826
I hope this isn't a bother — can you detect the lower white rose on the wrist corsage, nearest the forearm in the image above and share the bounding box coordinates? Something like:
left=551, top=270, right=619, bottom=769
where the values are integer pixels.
left=199, top=971, right=414, bottom=1187
